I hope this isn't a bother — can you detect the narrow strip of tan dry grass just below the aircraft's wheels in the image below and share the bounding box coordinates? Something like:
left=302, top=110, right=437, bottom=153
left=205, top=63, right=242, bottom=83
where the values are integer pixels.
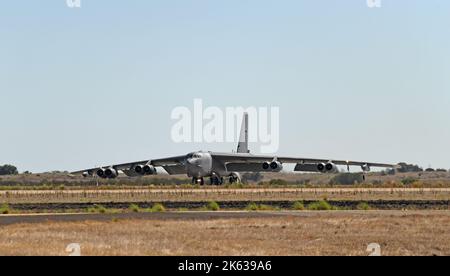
left=0, top=188, right=450, bottom=204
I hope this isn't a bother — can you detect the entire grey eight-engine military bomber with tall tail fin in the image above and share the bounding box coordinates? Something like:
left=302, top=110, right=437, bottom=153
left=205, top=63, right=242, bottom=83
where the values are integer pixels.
left=71, top=113, right=397, bottom=185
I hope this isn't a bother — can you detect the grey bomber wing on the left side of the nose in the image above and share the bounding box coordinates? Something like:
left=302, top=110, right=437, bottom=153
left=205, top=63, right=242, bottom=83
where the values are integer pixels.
left=71, top=155, right=186, bottom=175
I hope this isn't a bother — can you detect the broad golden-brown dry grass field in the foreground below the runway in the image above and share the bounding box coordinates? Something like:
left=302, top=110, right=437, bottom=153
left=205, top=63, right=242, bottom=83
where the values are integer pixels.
left=0, top=211, right=450, bottom=256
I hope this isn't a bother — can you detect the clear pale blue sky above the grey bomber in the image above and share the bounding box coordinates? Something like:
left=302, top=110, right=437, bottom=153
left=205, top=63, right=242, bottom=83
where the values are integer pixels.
left=0, top=0, right=450, bottom=172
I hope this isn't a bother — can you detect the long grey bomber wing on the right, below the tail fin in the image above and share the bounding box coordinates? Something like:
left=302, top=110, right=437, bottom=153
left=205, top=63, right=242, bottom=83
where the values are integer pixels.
left=212, top=153, right=397, bottom=170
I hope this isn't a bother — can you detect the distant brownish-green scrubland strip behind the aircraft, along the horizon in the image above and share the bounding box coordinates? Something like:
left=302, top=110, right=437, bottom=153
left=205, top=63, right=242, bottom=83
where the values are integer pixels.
left=0, top=172, right=450, bottom=189
